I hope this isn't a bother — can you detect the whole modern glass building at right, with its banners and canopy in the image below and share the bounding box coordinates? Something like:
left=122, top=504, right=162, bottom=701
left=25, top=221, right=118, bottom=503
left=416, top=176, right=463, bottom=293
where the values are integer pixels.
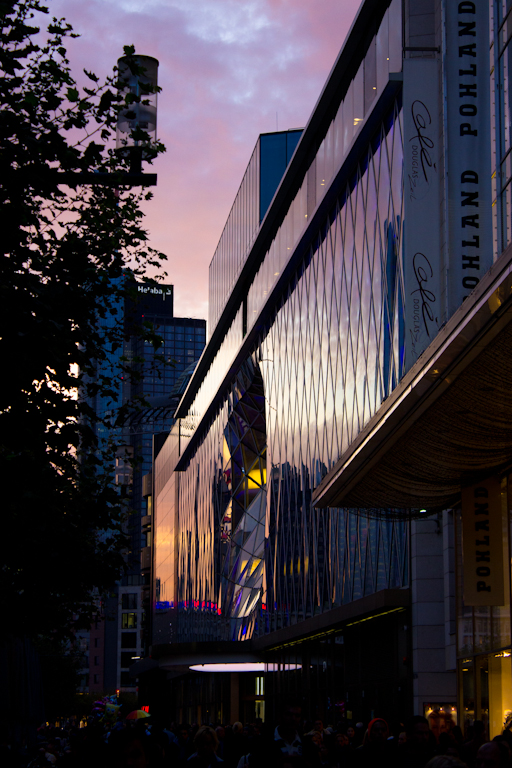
left=142, top=0, right=512, bottom=735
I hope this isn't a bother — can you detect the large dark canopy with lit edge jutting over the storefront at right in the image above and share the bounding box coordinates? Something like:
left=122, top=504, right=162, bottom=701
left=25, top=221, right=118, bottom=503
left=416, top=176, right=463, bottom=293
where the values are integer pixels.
left=313, top=247, right=512, bottom=509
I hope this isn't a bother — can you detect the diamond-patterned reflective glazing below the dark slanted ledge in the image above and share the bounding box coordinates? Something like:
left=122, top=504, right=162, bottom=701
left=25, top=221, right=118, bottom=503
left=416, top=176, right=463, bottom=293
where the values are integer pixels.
left=157, top=105, right=409, bottom=641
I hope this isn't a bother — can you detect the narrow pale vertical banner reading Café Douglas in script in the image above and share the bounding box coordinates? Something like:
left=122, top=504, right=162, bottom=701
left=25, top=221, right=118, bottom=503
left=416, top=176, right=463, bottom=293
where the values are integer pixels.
left=403, top=59, right=442, bottom=369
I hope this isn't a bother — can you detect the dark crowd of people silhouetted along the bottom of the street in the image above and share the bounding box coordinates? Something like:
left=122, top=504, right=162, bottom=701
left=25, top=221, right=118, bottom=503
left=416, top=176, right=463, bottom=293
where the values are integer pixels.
left=6, top=703, right=512, bottom=768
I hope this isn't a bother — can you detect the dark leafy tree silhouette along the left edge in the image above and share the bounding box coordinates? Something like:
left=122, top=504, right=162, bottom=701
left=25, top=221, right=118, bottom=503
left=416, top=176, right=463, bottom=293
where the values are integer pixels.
left=0, top=0, right=165, bottom=636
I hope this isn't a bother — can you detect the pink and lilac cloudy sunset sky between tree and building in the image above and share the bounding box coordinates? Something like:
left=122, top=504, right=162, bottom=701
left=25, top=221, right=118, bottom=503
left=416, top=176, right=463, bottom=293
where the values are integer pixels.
left=47, top=0, right=360, bottom=318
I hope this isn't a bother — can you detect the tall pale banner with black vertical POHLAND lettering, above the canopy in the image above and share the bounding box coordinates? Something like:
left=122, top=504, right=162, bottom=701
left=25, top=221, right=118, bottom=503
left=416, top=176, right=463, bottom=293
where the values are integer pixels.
left=445, top=0, right=492, bottom=317
